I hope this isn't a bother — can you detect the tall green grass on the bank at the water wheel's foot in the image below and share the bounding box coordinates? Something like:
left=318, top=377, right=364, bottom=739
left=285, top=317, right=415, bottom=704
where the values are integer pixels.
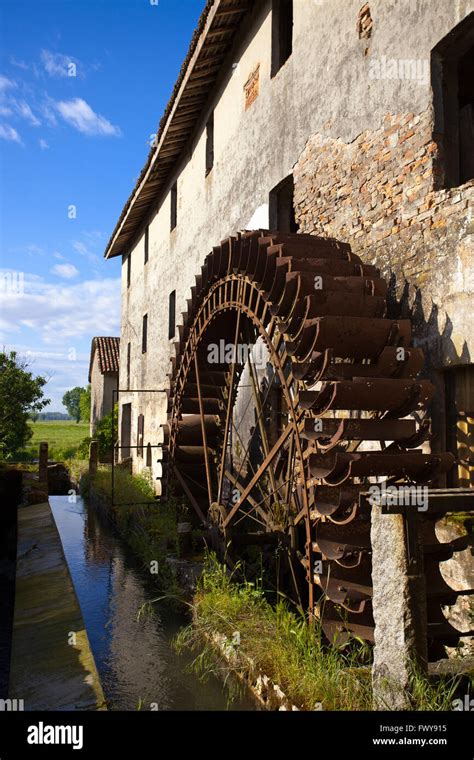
left=176, top=555, right=457, bottom=710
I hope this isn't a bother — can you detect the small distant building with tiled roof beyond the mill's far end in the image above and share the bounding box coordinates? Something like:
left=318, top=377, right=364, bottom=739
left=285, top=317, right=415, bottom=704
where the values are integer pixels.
left=89, top=337, right=120, bottom=435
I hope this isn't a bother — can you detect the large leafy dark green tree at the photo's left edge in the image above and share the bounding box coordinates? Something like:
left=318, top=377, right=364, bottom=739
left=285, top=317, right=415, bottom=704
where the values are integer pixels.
left=0, top=351, right=50, bottom=459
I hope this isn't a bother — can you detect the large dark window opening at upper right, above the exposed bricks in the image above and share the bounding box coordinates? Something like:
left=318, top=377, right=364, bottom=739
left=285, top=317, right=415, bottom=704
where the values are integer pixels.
left=431, top=13, right=474, bottom=188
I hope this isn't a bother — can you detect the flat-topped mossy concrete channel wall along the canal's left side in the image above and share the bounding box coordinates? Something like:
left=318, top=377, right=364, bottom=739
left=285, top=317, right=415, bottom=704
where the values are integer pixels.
left=8, top=502, right=106, bottom=710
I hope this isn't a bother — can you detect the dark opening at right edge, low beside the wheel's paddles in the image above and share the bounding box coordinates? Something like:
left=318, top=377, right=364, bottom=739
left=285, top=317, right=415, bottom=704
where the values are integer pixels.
left=445, top=364, right=474, bottom=488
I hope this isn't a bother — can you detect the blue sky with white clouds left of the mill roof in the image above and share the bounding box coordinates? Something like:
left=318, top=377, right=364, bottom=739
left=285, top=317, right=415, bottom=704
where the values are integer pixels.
left=0, top=0, right=204, bottom=411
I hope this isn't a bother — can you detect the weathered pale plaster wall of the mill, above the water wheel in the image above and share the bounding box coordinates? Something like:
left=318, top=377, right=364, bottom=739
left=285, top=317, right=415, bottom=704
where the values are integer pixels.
left=120, top=0, right=474, bottom=478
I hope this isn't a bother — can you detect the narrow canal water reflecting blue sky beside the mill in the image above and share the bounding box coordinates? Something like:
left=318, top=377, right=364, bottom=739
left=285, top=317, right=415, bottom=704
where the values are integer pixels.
left=49, top=496, right=255, bottom=710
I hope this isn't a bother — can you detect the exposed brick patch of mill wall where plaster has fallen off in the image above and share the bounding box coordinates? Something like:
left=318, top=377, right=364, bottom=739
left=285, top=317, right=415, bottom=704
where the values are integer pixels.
left=294, top=105, right=474, bottom=368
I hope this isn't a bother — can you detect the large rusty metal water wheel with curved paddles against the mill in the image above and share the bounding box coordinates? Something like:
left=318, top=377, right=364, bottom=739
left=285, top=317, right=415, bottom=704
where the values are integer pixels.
left=163, top=231, right=467, bottom=656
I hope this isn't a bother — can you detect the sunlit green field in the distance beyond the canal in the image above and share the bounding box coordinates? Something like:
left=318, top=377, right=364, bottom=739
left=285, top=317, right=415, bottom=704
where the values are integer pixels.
left=19, top=420, right=89, bottom=459
